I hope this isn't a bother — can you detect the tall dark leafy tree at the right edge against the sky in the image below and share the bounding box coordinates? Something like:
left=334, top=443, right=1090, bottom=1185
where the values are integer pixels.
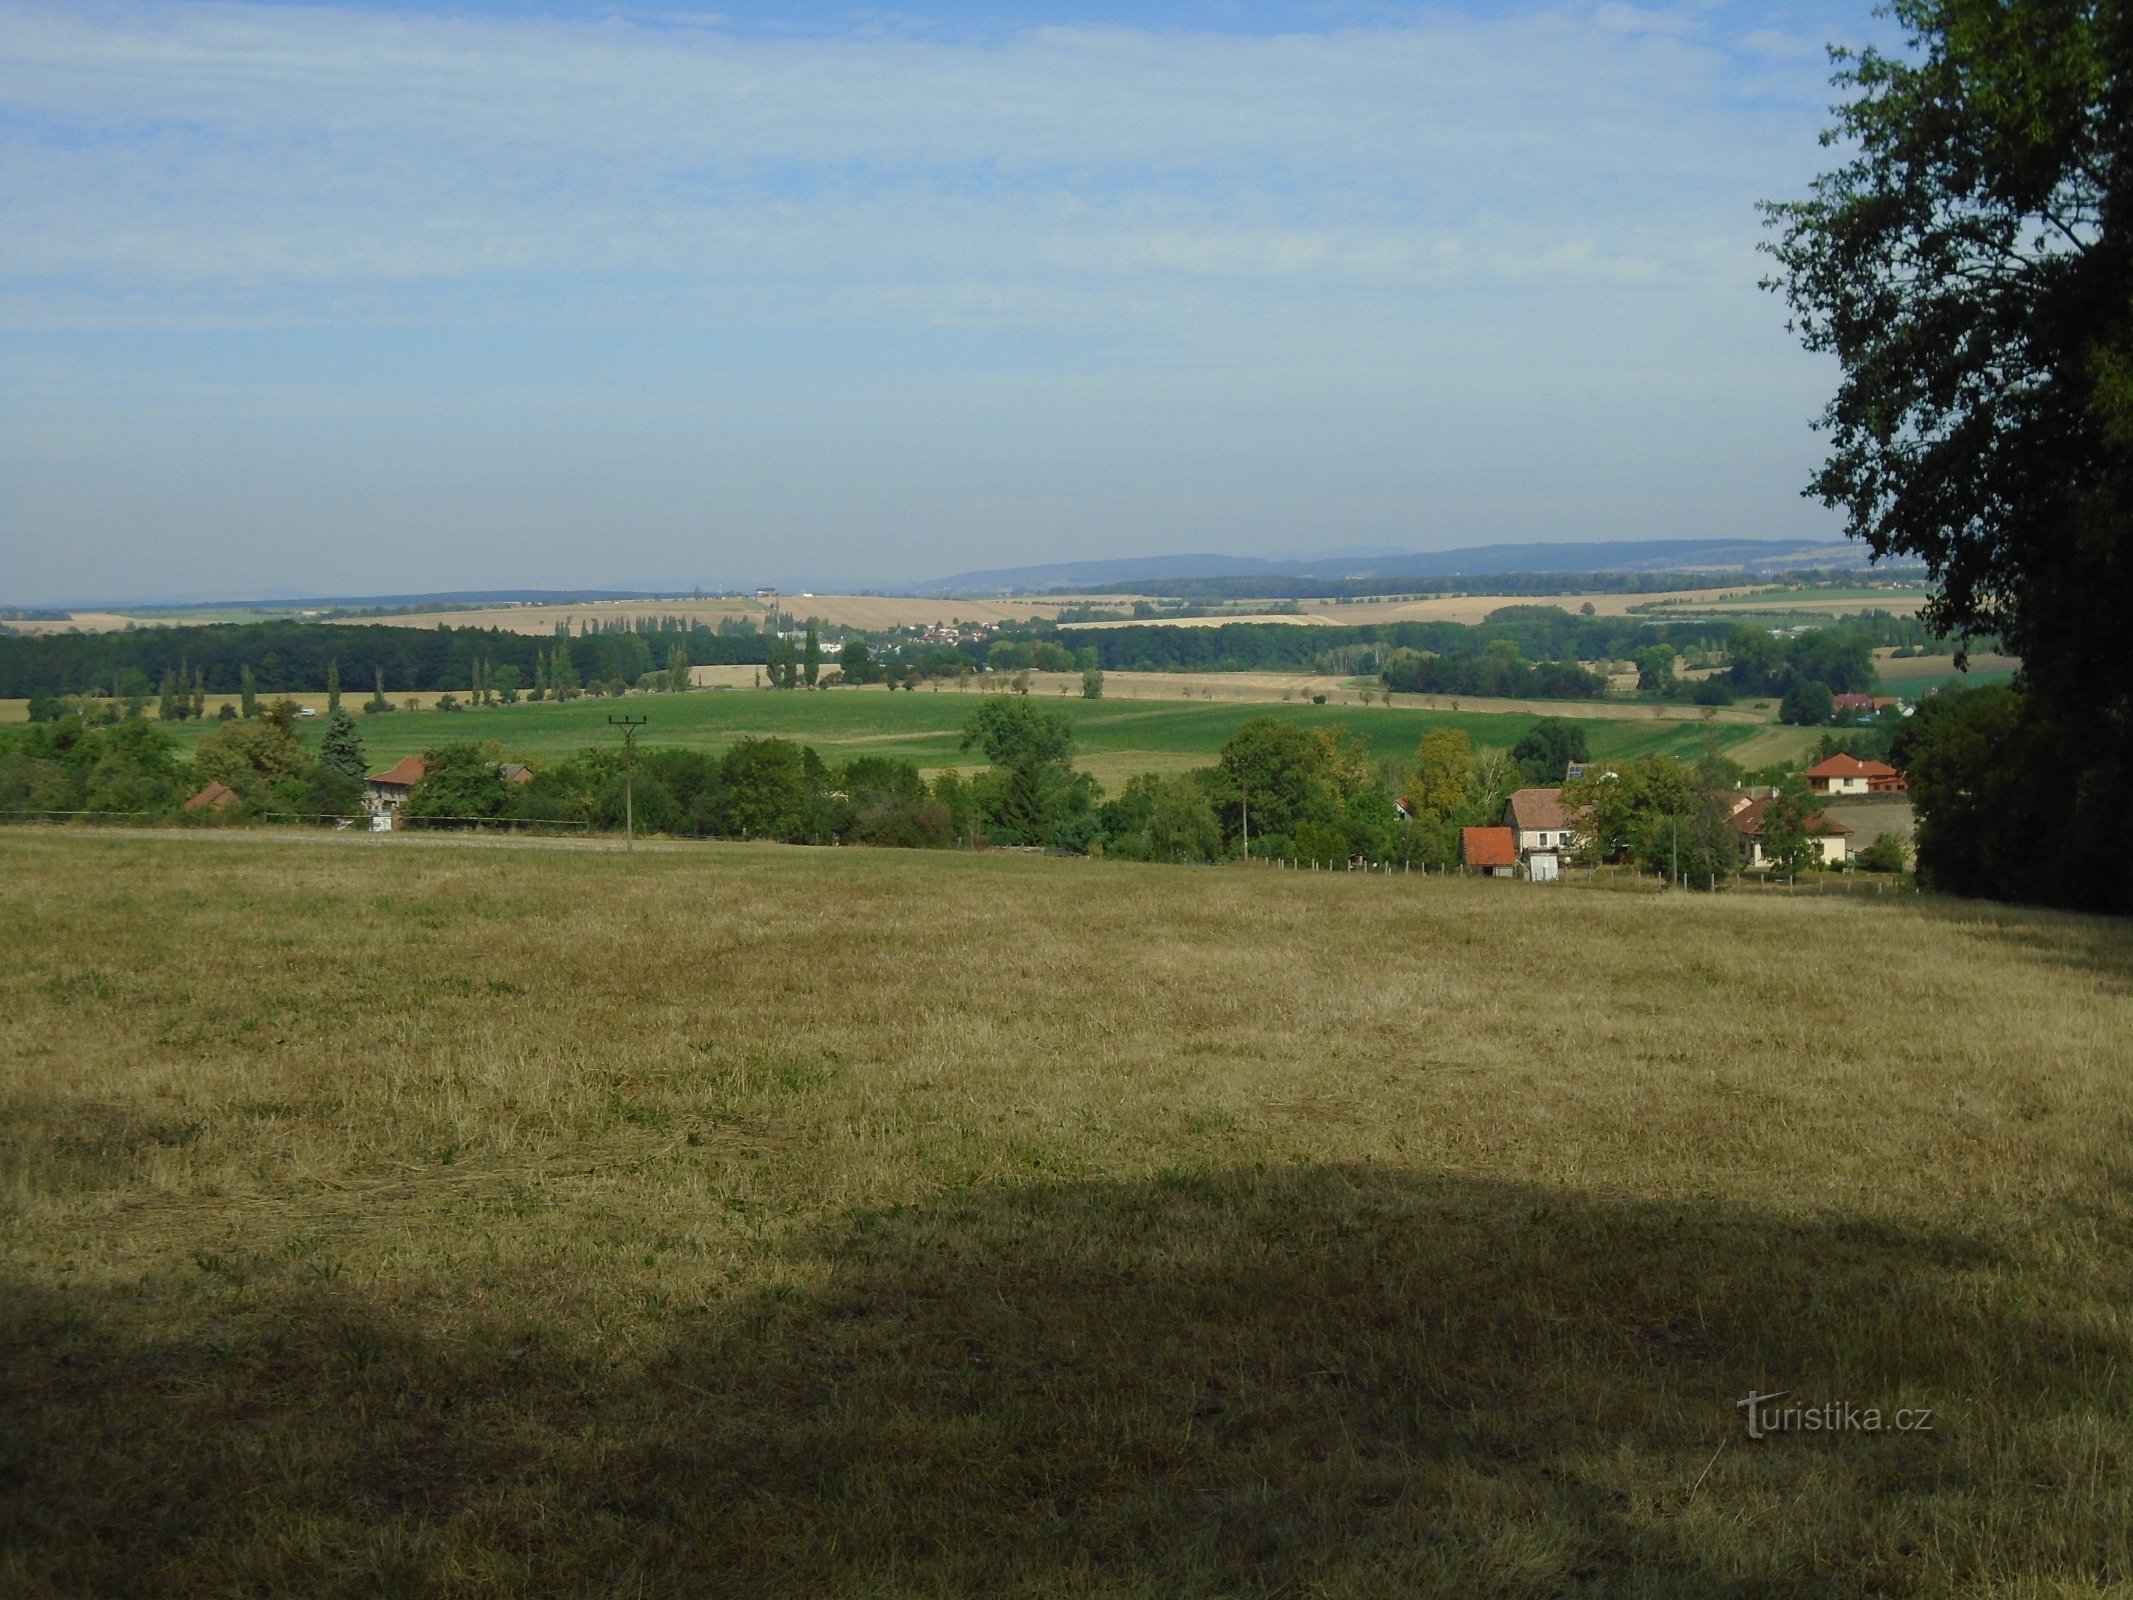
left=1766, top=0, right=2133, bottom=911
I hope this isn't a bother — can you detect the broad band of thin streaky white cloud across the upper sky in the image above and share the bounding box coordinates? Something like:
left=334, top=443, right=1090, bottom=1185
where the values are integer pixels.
left=0, top=4, right=1834, bottom=326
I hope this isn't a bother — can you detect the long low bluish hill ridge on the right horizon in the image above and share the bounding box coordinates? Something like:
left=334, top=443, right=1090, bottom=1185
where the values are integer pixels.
left=913, top=540, right=1866, bottom=595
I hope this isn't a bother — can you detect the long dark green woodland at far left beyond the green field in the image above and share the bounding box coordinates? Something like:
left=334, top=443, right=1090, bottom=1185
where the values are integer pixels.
left=0, top=621, right=768, bottom=698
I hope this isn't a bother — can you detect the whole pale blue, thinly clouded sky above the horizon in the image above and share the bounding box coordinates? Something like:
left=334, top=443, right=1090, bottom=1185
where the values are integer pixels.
left=0, top=0, right=1886, bottom=604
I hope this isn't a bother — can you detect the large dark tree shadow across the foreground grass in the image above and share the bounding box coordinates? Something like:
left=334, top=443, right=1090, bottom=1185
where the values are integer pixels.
left=0, top=1167, right=2127, bottom=1596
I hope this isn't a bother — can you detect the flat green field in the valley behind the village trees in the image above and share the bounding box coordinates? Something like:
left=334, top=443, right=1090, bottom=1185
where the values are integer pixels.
left=162, top=689, right=1790, bottom=787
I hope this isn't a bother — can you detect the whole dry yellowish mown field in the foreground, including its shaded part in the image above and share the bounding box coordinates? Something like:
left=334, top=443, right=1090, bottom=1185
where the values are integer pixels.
left=0, top=832, right=2133, bottom=1598
